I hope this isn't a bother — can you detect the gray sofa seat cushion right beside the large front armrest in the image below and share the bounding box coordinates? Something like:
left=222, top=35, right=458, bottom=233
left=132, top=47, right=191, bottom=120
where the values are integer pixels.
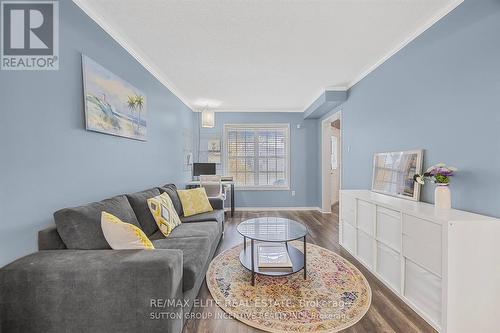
left=153, top=236, right=211, bottom=292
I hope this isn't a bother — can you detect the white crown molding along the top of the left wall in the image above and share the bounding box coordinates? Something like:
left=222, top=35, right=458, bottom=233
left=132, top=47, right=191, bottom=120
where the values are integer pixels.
left=73, top=0, right=193, bottom=110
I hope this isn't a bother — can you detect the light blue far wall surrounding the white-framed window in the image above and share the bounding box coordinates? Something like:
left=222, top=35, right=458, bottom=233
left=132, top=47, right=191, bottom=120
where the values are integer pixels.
left=194, top=112, right=319, bottom=207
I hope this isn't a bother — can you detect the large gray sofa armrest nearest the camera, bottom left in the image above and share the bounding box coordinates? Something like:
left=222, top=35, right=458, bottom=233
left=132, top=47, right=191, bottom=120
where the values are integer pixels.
left=0, top=249, right=183, bottom=332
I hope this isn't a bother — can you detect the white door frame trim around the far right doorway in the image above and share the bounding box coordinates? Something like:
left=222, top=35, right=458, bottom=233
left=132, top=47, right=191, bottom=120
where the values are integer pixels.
left=320, top=110, right=344, bottom=214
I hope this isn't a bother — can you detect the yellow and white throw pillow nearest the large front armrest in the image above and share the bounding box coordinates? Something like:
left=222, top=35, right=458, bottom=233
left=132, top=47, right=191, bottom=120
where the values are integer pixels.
left=101, top=212, right=155, bottom=250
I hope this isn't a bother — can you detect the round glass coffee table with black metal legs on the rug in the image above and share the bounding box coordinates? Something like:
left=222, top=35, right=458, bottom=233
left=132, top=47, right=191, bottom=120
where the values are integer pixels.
left=237, top=217, right=307, bottom=286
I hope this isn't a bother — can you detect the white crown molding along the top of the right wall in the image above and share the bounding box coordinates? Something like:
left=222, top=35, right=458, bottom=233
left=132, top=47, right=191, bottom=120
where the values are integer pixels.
left=348, top=0, right=464, bottom=89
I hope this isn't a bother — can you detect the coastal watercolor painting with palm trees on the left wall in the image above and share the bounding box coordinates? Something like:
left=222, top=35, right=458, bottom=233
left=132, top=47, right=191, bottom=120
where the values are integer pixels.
left=82, top=55, right=147, bottom=141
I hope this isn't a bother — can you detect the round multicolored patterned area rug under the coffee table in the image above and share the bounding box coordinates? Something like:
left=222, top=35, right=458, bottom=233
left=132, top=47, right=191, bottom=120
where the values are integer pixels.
left=206, top=242, right=371, bottom=332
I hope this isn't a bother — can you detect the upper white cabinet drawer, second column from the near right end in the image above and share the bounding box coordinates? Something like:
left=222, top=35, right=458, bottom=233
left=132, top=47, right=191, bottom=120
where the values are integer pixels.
left=376, top=207, right=401, bottom=251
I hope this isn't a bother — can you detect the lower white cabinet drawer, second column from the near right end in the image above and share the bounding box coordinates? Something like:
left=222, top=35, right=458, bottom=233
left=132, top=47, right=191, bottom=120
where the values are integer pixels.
left=376, top=242, right=401, bottom=293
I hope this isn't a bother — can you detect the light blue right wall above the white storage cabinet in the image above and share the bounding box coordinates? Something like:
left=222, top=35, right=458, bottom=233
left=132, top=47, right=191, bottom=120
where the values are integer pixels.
left=322, top=0, right=500, bottom=217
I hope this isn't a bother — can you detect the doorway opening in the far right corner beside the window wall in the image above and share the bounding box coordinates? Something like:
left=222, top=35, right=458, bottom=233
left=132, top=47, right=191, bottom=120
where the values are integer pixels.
left=321, top=111, right=342, bottom=213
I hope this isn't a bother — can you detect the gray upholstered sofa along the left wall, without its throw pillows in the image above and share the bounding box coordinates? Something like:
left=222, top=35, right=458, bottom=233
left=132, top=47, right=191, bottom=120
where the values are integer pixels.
left=0, top=184, right=224, bottom=332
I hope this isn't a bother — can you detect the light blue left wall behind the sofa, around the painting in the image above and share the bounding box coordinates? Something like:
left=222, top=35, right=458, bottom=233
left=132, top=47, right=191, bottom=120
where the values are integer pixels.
left=0, top=1, right=193, bottom=266
